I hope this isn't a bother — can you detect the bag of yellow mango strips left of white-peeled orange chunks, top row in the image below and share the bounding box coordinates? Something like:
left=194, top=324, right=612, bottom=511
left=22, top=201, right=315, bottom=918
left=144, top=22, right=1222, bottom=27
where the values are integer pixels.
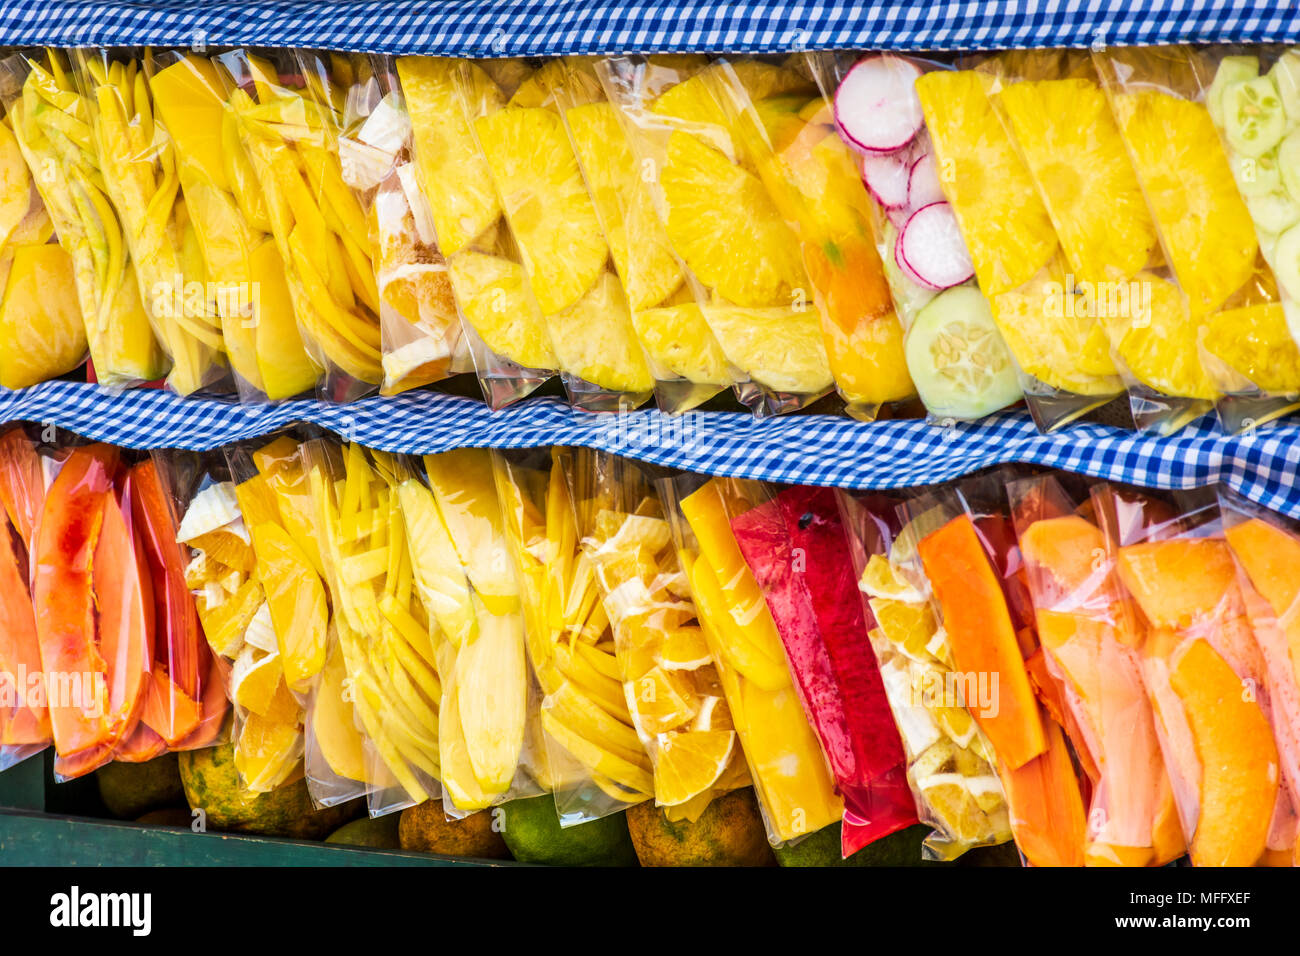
left=216, top=49, right=382, bottom=401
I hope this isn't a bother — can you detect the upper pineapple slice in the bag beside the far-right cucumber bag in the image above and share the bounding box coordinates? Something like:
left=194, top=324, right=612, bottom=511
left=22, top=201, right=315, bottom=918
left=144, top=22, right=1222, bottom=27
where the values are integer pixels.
left=1112, top=90, right=1258, bottom=315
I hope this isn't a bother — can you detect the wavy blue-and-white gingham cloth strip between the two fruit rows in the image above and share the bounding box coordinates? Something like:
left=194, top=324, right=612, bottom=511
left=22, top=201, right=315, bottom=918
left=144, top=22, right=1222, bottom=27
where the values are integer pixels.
left=0, top=381, right=1300, bottom=518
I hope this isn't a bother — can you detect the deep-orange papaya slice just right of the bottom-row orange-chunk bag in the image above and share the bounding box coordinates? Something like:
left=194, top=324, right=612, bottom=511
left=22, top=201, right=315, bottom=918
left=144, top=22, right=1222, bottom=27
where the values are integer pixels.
left=918, top=515, right=1050, bottom=770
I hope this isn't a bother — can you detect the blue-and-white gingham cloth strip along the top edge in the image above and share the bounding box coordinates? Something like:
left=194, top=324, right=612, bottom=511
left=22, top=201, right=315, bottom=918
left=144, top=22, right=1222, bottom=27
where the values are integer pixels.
left=0, top=0, right=1300, bottom=56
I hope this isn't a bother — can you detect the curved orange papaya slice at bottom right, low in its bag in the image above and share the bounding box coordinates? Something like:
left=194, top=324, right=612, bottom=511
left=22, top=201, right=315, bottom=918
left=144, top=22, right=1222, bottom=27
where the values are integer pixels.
left=1169, top=639, right=1278, bottom=866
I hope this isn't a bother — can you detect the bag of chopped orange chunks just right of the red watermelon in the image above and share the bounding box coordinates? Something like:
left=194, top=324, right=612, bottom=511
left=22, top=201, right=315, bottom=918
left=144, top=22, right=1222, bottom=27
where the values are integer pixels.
left=837, top=490, right=1011, bottom=860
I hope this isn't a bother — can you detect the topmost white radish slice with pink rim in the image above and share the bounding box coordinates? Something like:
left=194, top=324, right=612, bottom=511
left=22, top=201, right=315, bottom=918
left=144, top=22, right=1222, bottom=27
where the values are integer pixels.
left=835, top=55, right=924, bottom=152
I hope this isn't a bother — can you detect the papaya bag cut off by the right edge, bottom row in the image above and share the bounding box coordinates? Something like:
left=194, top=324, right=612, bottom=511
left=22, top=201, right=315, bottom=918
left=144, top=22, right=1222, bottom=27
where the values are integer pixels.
left=1218, top=486, right=1300, bottom=865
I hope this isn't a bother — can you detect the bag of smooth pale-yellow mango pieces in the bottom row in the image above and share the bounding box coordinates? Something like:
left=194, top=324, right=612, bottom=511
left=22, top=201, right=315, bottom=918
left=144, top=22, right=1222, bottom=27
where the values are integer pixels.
left=403, top=449, right=550, bottom=817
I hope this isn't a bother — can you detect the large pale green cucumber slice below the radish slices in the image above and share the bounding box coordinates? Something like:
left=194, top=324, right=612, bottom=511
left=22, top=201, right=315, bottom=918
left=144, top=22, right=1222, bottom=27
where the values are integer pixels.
left=904, top=285, right=1021, bottom=419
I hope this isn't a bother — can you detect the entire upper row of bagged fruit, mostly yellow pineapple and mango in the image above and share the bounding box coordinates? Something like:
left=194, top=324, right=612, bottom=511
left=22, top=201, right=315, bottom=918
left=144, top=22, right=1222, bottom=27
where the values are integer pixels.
left=0, top=47, right=1300, bottom=432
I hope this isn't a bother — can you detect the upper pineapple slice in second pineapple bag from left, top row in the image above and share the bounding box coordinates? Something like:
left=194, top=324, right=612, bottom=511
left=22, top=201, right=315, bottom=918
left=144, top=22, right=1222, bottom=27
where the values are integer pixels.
left=475, top=109, right=610, bottom=315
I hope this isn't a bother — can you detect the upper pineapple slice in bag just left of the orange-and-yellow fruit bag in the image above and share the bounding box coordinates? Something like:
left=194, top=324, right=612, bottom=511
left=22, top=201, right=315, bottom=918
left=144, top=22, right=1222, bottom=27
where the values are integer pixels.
left=660, top=131, right=810, bottom=308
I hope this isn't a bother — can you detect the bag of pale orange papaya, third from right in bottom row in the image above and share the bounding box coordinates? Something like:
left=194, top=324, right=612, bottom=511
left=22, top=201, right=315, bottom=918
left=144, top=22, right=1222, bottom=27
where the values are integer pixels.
left=1006, top=475, right=1186, bottom=866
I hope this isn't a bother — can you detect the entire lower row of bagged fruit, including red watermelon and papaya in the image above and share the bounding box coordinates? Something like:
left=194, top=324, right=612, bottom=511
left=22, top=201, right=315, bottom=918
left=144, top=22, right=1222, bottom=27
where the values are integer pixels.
left=10, top=428, right=1300, bottom=866
